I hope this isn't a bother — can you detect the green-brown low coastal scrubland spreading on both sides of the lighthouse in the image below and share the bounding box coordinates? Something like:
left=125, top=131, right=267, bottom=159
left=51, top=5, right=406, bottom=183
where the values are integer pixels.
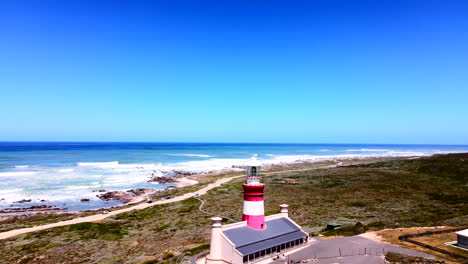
left=0, top=154, right=468, bottom=263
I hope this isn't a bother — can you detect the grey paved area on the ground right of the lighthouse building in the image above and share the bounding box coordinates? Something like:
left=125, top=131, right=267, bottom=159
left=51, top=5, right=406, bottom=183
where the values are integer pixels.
left=289, top=236, right=434, bottom=264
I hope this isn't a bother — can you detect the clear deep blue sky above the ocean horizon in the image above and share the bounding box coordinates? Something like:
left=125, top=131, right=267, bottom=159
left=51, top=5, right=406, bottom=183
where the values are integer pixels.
left=0, top=0, right=468, bottom=144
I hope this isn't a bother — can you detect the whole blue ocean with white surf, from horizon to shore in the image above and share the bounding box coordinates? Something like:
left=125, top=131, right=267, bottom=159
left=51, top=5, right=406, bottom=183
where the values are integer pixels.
left=0, top=142, right=468, bottom=211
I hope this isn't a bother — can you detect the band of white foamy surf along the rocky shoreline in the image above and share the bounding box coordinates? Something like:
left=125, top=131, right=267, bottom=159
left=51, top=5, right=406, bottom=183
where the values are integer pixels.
left=0, top=148, right=463, bottom=211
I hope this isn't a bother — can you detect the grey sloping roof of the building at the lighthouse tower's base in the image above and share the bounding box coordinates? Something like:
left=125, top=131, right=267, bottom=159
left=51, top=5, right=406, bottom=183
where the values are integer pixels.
left=223, top=217, right=307, bottom=256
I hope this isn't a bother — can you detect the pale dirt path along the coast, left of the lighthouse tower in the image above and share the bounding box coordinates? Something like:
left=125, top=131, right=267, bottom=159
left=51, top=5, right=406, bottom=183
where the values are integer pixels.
left=0, top=175, right=244, bottom=239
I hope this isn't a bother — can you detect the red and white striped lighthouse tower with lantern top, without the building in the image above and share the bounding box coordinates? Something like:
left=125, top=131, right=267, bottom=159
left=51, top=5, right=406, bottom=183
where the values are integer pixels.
left=242, top=157, right=265, bottom=229
